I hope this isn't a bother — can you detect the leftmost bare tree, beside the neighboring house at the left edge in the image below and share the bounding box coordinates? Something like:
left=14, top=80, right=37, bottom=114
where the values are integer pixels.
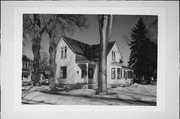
left=23, top=14, right=45, bottom=86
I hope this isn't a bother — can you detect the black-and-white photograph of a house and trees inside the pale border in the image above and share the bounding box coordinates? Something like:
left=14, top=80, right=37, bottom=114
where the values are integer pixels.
left=22, top=14, right=158, bottom=106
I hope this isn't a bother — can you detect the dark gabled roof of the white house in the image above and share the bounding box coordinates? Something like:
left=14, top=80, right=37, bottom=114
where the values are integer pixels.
left=63, top=36, right=116, bottom=62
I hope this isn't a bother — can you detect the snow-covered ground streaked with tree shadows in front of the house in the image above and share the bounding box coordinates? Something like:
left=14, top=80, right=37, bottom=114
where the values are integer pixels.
left=22, top=84, right=156, bottom=105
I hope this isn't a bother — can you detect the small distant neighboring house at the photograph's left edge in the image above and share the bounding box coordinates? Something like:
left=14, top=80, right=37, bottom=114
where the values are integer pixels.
left=22, top=55, right=33, bottom=80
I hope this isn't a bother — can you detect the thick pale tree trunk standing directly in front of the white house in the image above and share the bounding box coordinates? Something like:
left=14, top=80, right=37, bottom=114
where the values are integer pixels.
left=98, top=15, right=113, bottom=94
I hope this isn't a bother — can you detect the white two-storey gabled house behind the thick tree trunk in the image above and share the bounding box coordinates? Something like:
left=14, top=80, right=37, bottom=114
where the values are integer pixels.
left=55, top=36, right=133, bottom=88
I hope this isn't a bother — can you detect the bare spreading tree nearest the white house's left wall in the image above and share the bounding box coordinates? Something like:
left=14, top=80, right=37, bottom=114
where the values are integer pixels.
left=43, top=14, right=88, bottom=90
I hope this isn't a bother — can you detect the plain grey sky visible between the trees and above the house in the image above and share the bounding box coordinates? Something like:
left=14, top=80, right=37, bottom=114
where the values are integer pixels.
left=23, top=15, right=157, bottom=66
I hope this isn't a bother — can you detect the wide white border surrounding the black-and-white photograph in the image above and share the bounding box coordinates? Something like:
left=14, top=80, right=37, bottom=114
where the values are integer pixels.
left=1, top=1, right=179, bottom=119
